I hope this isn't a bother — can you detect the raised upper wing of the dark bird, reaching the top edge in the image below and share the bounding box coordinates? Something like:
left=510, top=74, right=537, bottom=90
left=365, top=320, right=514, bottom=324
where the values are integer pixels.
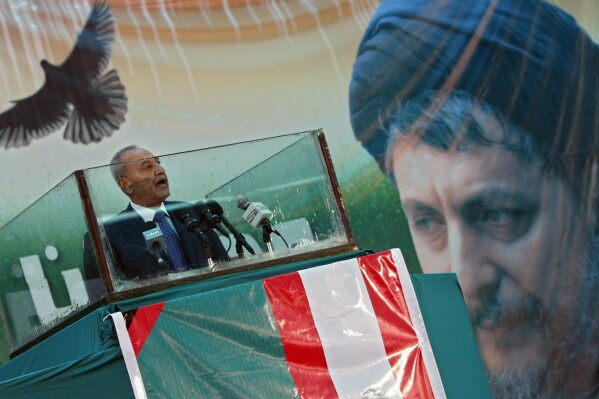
left=59, top=0, right=114, bottom=82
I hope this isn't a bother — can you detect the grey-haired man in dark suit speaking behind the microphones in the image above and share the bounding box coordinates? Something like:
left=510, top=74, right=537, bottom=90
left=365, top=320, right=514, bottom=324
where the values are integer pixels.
left=94, top=145, right=228, bottom=279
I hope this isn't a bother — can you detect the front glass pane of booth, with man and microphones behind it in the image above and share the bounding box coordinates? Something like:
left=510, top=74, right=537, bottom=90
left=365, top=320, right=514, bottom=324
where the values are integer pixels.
left=85, top=132, right=349, bottom=292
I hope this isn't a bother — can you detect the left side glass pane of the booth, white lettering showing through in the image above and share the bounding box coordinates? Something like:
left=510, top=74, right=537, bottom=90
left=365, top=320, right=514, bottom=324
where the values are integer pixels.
left=0, top=175, right=104, bottom=360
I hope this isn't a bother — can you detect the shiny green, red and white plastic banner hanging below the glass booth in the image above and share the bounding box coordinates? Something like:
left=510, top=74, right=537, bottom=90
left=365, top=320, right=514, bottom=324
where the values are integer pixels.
left=111, top=249, right=445, bottom=398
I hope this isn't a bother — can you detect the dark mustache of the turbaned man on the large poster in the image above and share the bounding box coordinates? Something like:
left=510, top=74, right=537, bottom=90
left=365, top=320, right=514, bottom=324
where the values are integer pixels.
left=470, top=295, right=545, bottom=328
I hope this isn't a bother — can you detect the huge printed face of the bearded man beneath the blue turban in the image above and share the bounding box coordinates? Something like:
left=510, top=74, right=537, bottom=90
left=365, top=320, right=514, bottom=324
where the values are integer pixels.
left=393, top=143, right=588, bottom=394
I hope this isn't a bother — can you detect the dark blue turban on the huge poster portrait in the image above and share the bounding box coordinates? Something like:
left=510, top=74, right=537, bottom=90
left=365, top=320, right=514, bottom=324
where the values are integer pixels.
left=349, top=0, right=599, bottom=167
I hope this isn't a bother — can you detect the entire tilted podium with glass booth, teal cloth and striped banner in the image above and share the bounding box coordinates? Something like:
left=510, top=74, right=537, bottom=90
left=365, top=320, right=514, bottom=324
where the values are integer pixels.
left=0, top=131, right=490, bottom=398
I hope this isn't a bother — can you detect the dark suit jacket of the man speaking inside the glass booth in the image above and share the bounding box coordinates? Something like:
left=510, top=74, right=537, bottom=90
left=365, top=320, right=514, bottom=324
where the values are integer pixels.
left=87, top=201, right=229, bottom=279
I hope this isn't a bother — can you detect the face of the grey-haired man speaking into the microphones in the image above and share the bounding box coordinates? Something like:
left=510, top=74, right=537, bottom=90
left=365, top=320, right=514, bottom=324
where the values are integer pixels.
left=118, top=150, right=170, bottom=207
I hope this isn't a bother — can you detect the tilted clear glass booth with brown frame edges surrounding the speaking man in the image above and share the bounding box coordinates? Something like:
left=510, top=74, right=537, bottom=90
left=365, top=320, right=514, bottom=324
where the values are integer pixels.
left=0, top=130, right=357, bottom=362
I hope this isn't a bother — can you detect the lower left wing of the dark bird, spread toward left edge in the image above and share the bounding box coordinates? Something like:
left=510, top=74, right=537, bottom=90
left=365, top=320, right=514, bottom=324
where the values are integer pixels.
left=0, top=85, right=70, bottom=149
